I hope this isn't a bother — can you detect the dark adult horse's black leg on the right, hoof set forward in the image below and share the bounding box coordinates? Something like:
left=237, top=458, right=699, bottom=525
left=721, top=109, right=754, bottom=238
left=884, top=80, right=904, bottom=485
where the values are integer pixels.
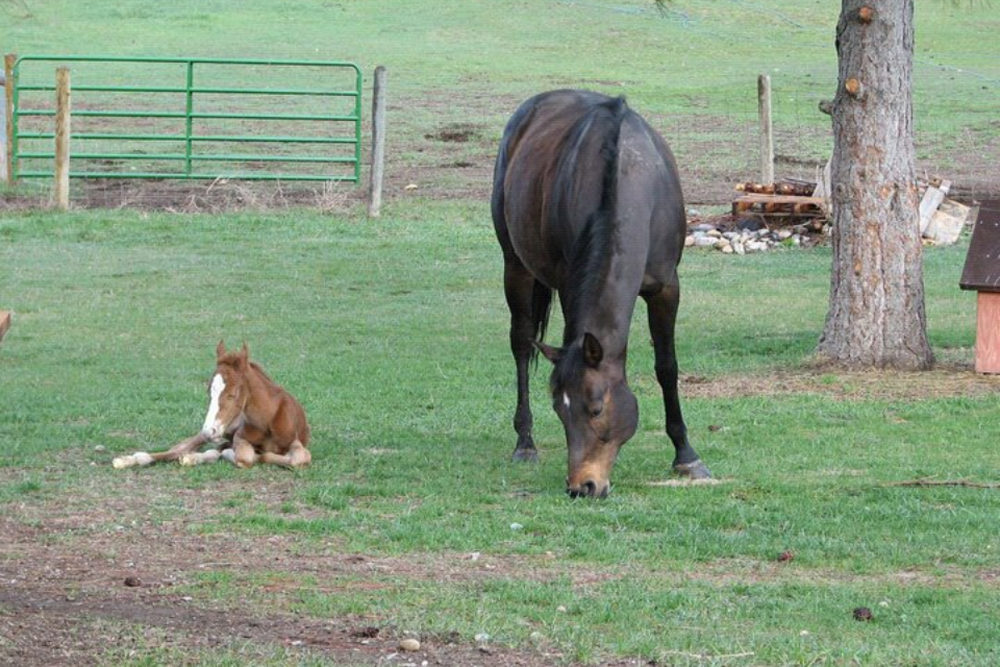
left=643, top=282, right=712, bottom=479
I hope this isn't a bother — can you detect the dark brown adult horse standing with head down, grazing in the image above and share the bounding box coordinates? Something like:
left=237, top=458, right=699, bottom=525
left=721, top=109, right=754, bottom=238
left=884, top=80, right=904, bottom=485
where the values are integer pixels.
left=491, top=90, right=710, bottom=498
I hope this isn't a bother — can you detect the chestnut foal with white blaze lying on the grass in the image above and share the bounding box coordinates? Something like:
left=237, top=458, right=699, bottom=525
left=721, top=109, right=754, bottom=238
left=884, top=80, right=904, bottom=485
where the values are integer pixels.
left=112, top=341, right=312, bottom=468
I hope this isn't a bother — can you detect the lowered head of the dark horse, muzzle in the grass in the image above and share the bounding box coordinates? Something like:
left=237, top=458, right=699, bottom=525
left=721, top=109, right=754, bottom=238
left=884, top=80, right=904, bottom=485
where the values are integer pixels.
left=537, top=333, right=639, bottom=498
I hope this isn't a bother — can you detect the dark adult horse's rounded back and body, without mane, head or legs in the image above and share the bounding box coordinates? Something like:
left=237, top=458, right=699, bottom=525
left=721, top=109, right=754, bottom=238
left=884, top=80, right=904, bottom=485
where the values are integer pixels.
left=492, top=90, right=684, bottom=289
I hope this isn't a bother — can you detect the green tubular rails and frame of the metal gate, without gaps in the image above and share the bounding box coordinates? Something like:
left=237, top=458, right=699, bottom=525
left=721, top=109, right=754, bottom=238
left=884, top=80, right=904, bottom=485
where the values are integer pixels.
left=8, top=55, right=362, bottom=182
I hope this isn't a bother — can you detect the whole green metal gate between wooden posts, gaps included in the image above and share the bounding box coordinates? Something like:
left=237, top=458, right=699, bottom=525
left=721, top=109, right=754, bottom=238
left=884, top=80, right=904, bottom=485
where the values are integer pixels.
left=9, top=55, right=362, bottom=182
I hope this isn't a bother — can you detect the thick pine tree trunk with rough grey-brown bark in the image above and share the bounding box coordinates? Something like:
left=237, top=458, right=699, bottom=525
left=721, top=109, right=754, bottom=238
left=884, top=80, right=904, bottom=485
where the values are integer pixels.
left=817, top=0, right=934, bottom=369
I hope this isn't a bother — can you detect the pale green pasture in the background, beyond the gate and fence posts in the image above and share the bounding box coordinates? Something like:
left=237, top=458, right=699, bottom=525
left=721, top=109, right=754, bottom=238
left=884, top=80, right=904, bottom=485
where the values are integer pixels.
left=0, top=0, right=1000, bottom=204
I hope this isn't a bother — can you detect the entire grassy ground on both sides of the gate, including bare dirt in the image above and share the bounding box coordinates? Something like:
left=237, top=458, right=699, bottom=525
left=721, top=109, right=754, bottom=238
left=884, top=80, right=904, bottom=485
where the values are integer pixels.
left=0, top=0, right=1000, bottom=667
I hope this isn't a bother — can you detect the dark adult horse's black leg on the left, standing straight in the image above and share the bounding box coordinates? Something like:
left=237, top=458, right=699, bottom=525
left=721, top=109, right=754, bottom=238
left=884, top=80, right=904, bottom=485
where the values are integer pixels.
left=503, top=258, right=538, bottom=461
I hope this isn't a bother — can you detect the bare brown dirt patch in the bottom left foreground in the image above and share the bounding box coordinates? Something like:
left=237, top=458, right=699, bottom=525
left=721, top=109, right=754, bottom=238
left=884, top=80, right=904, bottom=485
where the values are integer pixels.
left=0, top=480, right=625, bottom=667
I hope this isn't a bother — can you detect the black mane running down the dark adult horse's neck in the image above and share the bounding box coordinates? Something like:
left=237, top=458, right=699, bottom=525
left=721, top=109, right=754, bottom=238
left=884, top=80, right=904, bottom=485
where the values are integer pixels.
left=553, top=97, right=629, bottom=345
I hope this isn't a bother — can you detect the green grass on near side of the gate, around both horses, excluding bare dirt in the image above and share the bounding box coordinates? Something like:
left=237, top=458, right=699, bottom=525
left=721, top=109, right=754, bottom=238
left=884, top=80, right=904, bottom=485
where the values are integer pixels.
left=0, top=202, right=1000, bottom=665
